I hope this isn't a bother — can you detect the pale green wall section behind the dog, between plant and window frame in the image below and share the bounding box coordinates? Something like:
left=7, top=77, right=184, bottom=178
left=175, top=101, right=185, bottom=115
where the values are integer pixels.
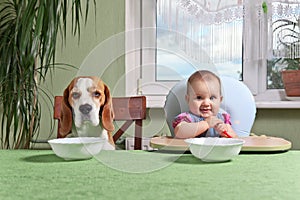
left=35, top=0, right=125, bottom=147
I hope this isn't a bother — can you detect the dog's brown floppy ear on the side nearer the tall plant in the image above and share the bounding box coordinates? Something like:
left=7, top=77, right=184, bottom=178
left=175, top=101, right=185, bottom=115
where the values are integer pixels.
left=60, top=83, right=73, bottom=137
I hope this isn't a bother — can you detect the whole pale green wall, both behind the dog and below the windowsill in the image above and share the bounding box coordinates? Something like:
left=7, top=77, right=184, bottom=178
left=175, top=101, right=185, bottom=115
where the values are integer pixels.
left=36, top=0, right=300, bottom=149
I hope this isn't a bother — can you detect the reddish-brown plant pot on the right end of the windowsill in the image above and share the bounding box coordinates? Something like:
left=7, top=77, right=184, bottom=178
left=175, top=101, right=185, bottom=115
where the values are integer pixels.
left=281, top=70, right=300, bottom=97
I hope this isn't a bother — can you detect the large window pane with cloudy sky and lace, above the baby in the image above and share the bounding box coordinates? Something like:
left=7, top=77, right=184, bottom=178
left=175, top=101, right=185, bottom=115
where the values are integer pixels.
left=155, top=0, right=243, bottom=81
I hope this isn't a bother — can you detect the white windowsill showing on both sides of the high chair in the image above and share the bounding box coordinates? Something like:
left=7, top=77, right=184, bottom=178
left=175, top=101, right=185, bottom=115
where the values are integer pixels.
left=147, top=96, right=300, bottom=109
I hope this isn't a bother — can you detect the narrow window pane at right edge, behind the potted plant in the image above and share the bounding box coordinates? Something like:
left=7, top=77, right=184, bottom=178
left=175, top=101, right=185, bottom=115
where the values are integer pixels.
left=267, top=2, right=300, bottom=89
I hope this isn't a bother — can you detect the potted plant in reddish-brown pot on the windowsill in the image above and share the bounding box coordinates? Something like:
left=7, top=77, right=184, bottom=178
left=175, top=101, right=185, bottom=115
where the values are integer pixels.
left=273, top=17, right=300, bottom=97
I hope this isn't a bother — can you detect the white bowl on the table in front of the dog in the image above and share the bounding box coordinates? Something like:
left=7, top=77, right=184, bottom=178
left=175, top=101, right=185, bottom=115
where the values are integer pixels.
left=48, top=137, right=105, bottom=160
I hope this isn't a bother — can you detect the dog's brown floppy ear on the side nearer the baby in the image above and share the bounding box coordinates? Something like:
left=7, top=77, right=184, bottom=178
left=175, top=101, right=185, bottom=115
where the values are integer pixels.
left=101, top=84, right=115, bottom=131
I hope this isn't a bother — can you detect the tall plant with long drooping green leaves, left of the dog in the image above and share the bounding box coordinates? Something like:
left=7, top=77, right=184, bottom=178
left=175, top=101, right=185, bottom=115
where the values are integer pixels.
left=0, top=0, right=96, bottom=148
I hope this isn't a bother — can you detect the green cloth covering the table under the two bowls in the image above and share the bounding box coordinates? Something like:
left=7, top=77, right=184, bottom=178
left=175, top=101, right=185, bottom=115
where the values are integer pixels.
left=0, top=150, right=300, bottom=200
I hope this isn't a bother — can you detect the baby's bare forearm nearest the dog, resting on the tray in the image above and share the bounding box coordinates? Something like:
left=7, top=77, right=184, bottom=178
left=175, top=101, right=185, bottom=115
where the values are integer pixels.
left=174, top=121, right=209, bottom=139
